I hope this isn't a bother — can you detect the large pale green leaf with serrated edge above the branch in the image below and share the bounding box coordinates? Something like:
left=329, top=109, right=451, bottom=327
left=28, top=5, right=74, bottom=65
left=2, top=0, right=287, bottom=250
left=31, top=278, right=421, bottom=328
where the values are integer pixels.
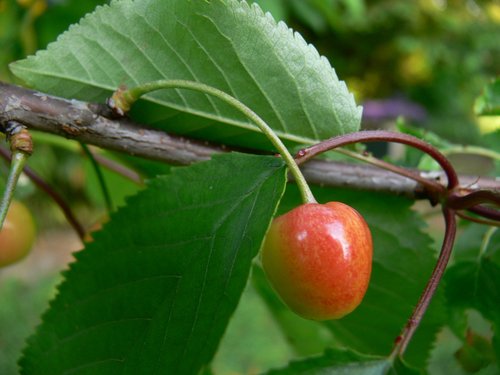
left=11, top=0, right=361, bottom=148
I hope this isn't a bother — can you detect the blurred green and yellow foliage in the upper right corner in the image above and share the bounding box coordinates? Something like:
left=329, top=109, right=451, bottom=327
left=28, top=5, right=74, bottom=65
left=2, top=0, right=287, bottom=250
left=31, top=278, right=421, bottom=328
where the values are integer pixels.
left=258, top=0, right=500, bottom=143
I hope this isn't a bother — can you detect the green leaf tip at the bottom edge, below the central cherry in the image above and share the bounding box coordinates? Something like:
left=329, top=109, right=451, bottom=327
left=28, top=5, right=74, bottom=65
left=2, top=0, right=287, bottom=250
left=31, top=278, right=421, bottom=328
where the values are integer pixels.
left=266, top=349, right=419, bottom=375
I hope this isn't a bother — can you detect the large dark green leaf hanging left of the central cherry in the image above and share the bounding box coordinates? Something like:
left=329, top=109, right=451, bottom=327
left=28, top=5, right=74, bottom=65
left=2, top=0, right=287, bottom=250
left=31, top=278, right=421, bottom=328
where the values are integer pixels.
left=21, top=154, right=286, bottom=375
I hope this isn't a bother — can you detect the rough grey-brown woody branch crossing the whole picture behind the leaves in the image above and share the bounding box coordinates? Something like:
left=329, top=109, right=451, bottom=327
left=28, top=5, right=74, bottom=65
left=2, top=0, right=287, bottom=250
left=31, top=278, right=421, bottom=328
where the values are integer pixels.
left=0, top=83, right=500, bottom=199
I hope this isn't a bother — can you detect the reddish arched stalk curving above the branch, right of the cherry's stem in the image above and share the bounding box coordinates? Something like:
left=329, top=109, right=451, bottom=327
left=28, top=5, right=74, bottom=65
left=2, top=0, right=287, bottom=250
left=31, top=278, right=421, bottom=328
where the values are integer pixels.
left=296, top=130, right=459, bottom=190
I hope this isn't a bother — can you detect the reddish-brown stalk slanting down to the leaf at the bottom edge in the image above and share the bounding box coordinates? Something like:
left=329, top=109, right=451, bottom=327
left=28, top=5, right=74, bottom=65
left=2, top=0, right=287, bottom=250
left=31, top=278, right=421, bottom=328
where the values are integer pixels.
left=390, top=207, right=457, bottom=359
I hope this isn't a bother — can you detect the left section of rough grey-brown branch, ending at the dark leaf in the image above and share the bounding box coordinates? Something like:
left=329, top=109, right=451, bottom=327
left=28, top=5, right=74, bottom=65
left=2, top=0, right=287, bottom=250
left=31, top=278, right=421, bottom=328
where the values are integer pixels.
left=0, top=83, right=223, bottom=165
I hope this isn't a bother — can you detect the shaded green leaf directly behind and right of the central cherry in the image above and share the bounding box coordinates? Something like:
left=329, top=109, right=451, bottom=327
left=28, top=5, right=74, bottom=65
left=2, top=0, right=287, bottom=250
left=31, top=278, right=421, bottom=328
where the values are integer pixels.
left=272, top=189, right=445, bottom=367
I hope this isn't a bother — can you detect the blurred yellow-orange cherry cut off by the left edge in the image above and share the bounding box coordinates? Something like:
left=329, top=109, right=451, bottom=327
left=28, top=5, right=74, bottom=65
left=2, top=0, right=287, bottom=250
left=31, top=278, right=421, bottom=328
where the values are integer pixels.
left=0, top=200, right=36, bottom=267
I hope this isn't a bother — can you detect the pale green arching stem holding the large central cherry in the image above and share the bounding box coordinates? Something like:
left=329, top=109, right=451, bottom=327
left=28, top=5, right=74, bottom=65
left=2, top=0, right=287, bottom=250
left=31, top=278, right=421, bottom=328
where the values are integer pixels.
left=108, top=80, right=316, bottom=203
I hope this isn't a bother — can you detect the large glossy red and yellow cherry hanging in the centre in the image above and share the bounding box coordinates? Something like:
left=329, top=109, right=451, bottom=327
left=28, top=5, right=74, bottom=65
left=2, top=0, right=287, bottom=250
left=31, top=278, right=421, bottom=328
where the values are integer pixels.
left=262, top=202, right=373, bottom=320
